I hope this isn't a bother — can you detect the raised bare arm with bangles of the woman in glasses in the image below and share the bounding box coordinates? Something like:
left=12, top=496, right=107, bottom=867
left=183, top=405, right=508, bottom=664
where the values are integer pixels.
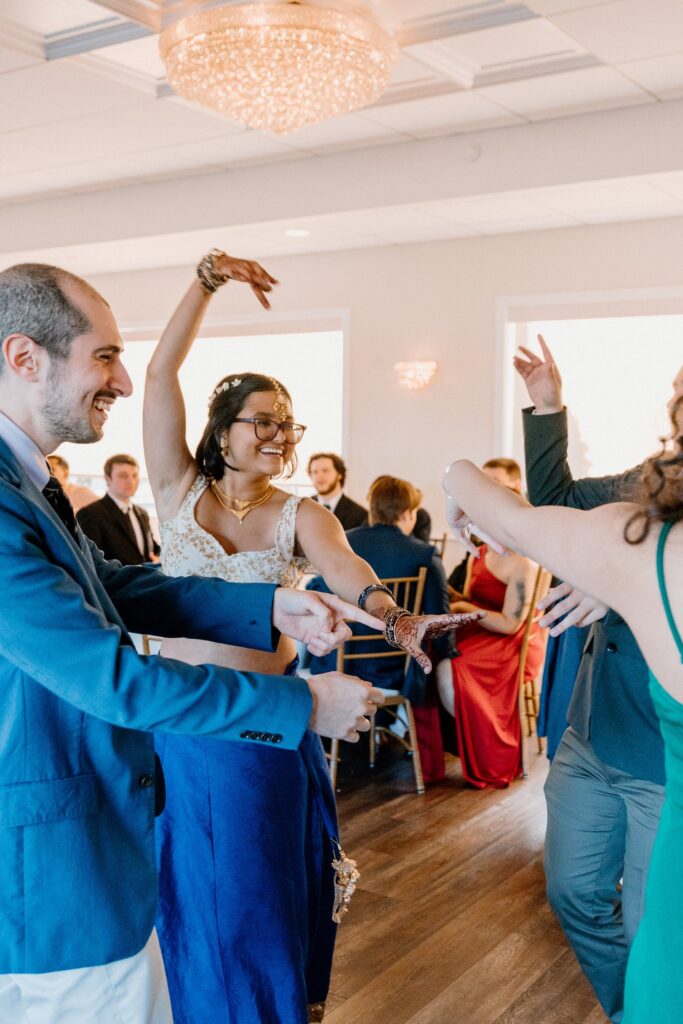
left=142, top=250, right=276, bottom=519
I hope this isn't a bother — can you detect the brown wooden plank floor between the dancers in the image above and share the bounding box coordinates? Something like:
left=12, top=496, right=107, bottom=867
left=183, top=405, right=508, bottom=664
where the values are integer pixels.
left=325, top=744, right=605, bottom=1024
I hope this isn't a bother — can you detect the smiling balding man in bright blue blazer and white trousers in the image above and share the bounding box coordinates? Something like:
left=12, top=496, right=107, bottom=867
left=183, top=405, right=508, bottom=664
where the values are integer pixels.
left=0, top=264, right=382, bottom=1024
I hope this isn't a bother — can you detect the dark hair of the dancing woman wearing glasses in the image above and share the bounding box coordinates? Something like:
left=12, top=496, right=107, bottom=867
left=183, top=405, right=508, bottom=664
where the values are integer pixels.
left=195, top=373, right=297, bottom=480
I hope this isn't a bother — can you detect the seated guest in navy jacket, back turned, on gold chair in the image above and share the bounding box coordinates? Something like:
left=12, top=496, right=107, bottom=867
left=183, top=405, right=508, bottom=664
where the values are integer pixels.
left=308, top=476, right=455, bottom=703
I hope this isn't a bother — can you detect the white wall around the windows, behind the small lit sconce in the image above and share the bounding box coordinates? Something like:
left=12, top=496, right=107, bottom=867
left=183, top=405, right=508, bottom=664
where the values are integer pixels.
left=91, top=219, right=683, bottom=565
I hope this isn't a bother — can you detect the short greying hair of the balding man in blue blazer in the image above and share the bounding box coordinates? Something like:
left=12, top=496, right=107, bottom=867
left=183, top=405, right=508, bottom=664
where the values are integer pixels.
left=0, top=263, right=105, bottom=373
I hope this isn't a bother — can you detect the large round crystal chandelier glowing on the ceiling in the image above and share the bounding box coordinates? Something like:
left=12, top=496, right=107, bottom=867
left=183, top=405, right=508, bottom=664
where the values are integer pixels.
left=159, top=2, right=398, bottom=134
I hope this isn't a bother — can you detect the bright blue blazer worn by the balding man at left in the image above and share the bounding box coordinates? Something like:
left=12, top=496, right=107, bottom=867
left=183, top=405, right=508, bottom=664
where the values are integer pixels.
left=0, top=441, right=311, bottom=974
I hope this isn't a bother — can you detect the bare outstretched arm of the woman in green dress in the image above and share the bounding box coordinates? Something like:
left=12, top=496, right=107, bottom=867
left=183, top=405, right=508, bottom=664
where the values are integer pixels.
left=443, top=460, right=632, bottom=611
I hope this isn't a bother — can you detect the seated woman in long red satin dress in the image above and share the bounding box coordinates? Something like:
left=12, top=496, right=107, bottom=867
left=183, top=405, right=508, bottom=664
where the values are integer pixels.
left=437, top=459, right=544, bottom=788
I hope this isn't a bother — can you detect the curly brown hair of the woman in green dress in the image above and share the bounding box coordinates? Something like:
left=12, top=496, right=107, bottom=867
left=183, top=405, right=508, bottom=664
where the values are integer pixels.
left=624, top=395, right=683, bottom=544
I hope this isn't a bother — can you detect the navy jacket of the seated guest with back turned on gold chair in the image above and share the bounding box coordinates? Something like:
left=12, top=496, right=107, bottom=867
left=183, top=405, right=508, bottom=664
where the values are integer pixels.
left=308, top=523, right=455, bottom=705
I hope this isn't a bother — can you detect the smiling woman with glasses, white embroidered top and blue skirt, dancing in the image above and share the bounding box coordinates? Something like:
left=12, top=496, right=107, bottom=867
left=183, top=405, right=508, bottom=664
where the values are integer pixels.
left=144, top=251, right=479, bottom=1024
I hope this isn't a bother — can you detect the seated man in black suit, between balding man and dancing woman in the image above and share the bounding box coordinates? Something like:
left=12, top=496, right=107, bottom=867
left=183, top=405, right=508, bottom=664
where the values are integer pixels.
left=77, top=455, right=160, bottom=565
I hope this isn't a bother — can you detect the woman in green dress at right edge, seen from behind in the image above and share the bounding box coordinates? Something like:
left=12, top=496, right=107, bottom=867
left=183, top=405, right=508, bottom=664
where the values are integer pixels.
left=443, top=385, right=683, bottom=1024
